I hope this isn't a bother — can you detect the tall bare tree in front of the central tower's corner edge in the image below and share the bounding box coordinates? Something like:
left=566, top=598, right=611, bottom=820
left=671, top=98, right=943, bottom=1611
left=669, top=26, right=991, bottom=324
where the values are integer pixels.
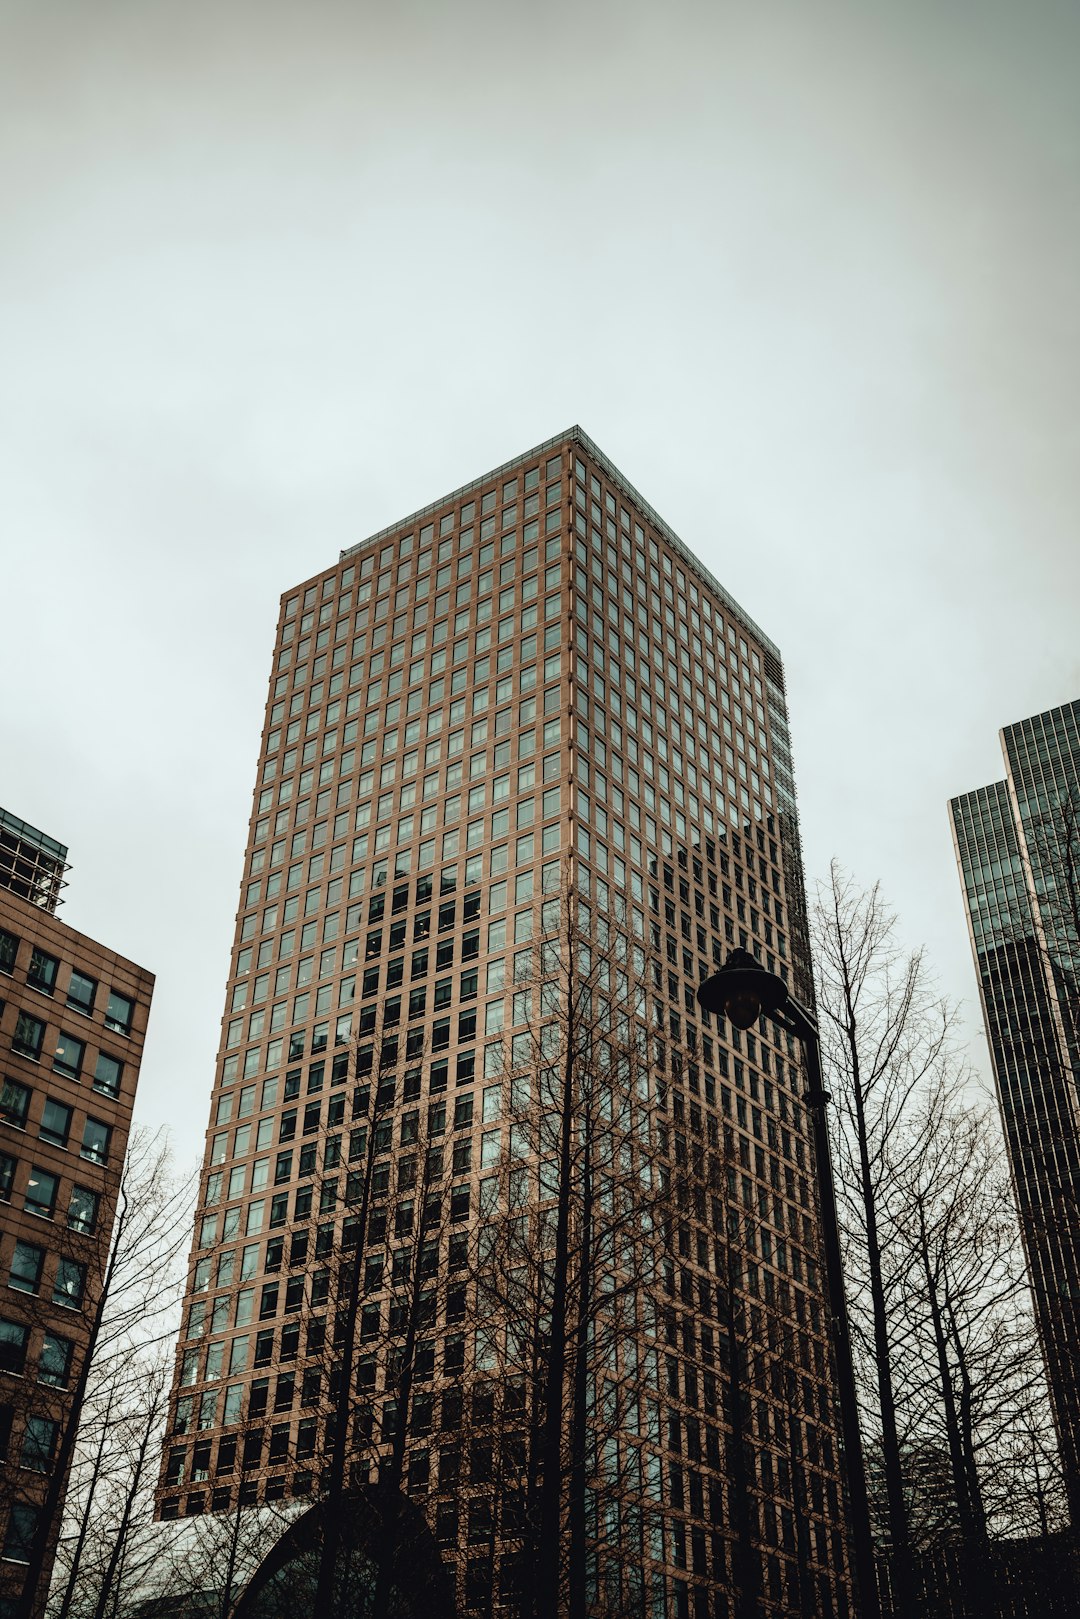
left=473, top=869, right=672, bottom=1619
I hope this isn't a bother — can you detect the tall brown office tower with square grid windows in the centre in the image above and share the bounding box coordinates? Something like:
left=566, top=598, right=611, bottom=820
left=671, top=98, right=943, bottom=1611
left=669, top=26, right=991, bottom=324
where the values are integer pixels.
left=159, top=427, right=848, bottom=1619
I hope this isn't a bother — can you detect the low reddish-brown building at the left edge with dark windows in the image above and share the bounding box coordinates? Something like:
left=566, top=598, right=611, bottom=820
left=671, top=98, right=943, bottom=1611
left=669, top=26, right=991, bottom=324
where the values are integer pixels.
left=0, top=810, right=154, bottom=1601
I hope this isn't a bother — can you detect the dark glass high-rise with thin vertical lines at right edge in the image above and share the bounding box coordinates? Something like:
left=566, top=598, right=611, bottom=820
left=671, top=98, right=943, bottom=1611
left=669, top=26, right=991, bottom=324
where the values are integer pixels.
left=949, top=703, right=1080, bottom=1523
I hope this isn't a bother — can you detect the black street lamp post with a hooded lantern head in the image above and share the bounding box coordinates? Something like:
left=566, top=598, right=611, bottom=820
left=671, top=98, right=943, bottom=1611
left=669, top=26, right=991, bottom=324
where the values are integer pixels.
left=698, top=950, right=881, bottom=1619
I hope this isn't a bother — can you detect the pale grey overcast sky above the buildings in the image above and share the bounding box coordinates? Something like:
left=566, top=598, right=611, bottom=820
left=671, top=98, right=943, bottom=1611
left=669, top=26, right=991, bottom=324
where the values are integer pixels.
left=0, top=0, right=1080, bottom=1156
